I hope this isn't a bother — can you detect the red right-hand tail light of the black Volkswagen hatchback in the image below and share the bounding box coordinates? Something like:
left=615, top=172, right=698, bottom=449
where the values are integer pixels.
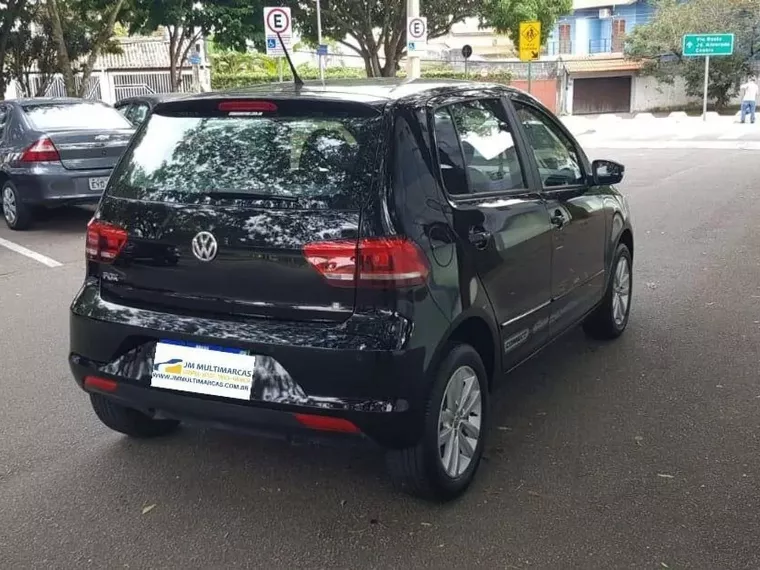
left=303, top=237, right=429, bottom=289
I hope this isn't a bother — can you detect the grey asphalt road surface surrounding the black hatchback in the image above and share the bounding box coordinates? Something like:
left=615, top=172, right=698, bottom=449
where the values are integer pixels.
left=0, top=150, right=760, bottom=570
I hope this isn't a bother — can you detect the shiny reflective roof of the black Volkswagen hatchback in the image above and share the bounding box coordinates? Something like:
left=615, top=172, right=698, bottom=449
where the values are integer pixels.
left=155, top=78, right=519, bottom=105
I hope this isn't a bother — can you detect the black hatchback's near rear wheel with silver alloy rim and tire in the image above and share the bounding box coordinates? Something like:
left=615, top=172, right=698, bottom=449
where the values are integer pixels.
left=386, top=344, right=489, bottom=501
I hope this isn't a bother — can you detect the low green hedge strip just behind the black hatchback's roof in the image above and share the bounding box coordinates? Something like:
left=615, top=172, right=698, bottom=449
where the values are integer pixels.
left=211, top=61, right=512, bottom=89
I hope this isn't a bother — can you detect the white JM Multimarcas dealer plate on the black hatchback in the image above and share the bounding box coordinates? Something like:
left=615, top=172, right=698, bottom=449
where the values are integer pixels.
left=150, top=342, right=256, bottom=400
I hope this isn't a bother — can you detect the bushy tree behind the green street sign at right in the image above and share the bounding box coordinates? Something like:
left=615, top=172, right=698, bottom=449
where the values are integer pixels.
left=626, top=0, right=760, bottom=108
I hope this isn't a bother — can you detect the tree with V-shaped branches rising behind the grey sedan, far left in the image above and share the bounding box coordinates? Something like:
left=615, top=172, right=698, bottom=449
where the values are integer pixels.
left=46, top=0, right=126, bottom=97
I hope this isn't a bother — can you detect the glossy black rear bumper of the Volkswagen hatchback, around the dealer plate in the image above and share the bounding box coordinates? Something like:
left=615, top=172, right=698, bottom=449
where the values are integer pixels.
left=69, top=281, right=425, bottom=447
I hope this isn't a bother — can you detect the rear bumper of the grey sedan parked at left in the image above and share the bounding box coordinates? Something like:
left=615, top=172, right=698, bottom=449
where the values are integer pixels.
left=9, top=166, right=112, bottom=206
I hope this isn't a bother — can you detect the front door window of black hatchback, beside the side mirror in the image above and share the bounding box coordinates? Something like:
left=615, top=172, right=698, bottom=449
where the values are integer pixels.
left=515, top=101, right=585, bottom=188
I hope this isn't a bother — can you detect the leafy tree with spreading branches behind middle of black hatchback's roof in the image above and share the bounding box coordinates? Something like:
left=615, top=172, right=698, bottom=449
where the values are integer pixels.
left=286, top=0, right=482, bottom=77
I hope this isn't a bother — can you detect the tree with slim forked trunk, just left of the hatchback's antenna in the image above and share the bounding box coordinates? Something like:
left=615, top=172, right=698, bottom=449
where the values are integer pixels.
left=125, top=0, right=264, bottom=91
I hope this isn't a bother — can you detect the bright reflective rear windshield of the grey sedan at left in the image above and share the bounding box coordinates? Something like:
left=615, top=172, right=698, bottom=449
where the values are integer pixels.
left=24, top=103, right=132, bottom=131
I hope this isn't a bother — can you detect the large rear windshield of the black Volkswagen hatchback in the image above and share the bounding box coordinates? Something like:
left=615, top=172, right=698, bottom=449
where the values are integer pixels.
left=109, top=105, right=381, bottom=208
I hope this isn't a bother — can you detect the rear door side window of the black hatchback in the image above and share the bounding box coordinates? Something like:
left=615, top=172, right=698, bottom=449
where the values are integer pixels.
left=435, top=99, right=525, bottom=194
